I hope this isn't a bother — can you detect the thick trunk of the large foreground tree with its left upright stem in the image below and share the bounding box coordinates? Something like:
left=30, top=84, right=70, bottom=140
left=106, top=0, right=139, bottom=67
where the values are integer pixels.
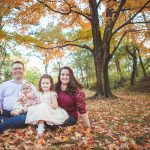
left=89, top=0, right=113, bottom=98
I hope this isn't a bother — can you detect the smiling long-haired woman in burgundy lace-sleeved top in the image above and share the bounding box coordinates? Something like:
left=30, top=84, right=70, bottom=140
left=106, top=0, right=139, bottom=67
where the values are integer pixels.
left=55, top=67, right=91, bottom=128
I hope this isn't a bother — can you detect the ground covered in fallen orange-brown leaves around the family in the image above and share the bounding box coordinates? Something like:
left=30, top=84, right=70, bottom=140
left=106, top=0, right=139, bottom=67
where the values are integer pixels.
left=0, top=93, right=150, bottom=150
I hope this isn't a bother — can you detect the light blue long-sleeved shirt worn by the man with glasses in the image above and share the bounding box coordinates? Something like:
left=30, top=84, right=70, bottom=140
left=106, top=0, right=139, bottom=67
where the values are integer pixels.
left=0, top=80, right=38, bottom=111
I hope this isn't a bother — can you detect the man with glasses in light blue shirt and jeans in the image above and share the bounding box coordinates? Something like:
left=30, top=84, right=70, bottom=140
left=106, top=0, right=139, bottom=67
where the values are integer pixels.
left=0, top=61, right=37, bottom=133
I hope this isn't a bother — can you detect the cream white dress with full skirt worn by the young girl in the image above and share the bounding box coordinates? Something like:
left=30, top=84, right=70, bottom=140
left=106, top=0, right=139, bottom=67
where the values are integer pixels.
left=25, top=92, right=69, bottom=125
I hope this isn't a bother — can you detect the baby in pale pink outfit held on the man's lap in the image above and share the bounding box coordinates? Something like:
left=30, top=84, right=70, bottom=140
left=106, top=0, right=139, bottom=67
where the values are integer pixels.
left=11, top=82, right=37, bottom=116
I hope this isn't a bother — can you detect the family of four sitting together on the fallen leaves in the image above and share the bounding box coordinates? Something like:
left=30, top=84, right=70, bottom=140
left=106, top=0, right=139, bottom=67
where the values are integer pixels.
left=0, top=61, right=91, bottom=134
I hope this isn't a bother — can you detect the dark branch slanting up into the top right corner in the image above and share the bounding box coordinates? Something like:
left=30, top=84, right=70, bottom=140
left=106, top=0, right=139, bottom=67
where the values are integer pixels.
left=112, top=0, right=150, bottom=36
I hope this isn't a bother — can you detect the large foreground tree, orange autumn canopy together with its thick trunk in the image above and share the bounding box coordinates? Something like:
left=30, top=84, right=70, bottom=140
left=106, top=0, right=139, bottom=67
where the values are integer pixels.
left=0, top=0, right=150, bottom=97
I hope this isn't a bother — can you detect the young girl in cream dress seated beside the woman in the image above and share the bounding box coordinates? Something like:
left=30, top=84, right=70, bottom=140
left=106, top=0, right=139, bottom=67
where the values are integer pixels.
left=26, top=74, right=69, bottom=134
